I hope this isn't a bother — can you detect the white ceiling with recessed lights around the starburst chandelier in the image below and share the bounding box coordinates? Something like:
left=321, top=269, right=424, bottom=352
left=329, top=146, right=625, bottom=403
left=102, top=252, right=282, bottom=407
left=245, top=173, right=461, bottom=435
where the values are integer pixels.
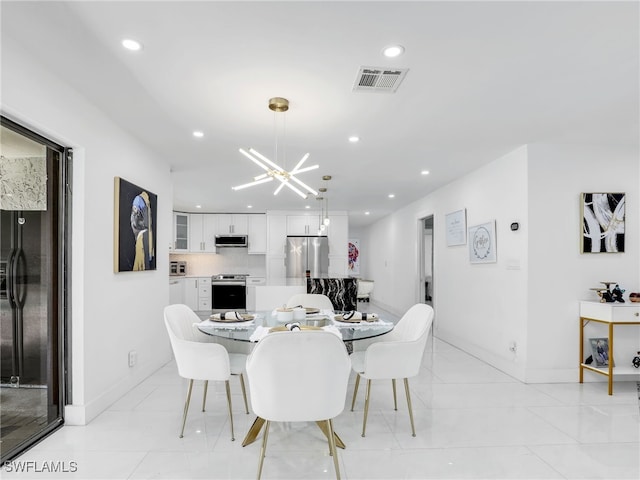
left=2, top=1, right=639, bottom=226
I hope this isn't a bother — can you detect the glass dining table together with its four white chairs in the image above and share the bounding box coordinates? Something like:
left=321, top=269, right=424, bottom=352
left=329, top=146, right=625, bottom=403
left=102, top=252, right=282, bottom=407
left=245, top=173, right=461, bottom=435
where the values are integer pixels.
left=164, top=294, right=433, bottom=478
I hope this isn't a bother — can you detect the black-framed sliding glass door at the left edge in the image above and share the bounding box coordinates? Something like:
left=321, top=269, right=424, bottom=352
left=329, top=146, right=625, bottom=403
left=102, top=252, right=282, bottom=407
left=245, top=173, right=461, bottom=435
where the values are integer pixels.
left=0, top=117, right=70, bottom=463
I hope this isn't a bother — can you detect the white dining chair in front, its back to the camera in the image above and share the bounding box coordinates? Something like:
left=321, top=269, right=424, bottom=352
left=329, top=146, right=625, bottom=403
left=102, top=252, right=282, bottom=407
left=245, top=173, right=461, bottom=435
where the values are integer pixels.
left=247, top=330, right=351, bottom=479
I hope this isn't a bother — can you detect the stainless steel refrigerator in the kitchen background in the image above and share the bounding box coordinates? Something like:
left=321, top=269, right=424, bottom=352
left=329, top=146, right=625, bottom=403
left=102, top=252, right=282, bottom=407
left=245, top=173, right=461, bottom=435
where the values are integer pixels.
left=286, top=236, right=329, bottom=278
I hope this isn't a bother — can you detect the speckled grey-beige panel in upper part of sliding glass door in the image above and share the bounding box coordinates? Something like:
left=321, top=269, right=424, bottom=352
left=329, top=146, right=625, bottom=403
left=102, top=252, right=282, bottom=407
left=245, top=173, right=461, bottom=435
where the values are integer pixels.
left=0, top=156, right=47, bottom=210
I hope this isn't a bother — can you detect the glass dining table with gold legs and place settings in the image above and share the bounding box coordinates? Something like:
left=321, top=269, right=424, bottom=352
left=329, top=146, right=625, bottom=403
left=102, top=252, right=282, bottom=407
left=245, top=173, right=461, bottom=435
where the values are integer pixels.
left=195, top=311, right=394, bottom=448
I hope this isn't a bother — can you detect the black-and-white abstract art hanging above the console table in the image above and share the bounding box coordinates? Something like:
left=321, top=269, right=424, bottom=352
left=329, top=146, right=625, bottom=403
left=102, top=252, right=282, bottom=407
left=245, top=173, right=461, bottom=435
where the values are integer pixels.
left=581, top=193, right=625, bottom=253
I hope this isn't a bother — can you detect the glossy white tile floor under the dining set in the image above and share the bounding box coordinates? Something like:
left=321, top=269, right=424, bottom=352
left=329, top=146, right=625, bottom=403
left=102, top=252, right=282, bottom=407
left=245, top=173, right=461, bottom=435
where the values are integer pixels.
left=1, top=305, right=640, bottom=480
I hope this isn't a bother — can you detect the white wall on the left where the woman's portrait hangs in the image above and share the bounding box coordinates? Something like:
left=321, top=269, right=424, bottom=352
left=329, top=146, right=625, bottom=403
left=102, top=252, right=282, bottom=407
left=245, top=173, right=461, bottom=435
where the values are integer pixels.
left=1, top=35, right=172, bottom=424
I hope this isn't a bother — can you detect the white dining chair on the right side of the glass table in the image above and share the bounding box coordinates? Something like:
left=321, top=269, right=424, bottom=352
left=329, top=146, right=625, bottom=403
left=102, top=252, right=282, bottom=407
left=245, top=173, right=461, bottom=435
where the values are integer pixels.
left=351, top=303, right=433, bottom=437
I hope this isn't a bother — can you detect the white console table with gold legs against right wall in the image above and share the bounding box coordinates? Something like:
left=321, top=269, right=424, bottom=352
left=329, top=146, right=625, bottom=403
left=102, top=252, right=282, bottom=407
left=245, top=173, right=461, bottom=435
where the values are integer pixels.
left=580, top=301, right=640, bottom=395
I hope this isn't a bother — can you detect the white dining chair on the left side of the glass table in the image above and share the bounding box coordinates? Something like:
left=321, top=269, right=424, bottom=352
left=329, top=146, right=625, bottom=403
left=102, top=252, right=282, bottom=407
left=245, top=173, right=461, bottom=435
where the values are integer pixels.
left=164, top=304, right=249, bottom=440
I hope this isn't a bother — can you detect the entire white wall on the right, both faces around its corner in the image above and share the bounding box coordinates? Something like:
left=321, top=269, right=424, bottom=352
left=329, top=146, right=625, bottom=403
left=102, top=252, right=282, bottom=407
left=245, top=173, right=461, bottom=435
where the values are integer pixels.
left=361, top=145, right=640, bottom=382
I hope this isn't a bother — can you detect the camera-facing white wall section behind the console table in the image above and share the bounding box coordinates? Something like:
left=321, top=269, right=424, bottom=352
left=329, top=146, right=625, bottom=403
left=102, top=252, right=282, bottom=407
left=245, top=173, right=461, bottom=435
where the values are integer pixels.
left=526, top=145, right=640, bottom=382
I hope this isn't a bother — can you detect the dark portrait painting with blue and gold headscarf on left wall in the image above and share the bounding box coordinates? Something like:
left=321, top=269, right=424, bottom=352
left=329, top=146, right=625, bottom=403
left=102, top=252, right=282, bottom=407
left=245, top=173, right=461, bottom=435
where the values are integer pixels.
left=114, top=177, right=158, bottom=272
